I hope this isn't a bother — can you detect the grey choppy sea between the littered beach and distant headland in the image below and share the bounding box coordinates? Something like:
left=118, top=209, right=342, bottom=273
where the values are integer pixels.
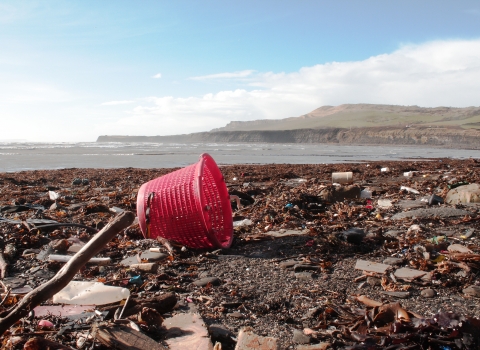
left=0, top=142, right=480, bottom=172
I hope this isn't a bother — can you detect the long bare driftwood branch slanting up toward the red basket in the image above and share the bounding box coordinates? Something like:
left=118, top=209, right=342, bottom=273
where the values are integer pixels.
left=0, top=212, right=135, bottom=335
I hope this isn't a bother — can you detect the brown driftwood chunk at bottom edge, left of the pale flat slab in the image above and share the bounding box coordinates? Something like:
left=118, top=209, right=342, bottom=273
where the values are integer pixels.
left=94, top=326, right=167, bottom=350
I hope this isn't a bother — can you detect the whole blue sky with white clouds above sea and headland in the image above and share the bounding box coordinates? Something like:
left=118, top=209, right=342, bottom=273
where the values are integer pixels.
left=0, top=0, right=480, bottom=142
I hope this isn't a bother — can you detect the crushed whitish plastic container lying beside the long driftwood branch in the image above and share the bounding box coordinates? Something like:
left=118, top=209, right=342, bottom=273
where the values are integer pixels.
left=53, top=281, right=130, bottom=305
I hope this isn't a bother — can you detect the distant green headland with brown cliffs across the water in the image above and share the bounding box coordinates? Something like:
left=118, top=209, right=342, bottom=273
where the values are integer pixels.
left=97, top=104, right=480, bottom=149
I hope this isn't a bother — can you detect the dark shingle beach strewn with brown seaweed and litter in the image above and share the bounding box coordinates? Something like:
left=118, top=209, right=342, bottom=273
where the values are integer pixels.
left=0, top=158, right=480, bottom=349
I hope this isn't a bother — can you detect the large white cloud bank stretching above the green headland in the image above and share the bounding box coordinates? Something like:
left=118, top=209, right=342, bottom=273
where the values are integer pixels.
left=105, top=40, right=480, bottom=135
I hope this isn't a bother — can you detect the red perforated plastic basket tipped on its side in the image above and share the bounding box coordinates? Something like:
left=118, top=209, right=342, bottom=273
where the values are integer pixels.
left=137, top=153, right=233, bottom=248
